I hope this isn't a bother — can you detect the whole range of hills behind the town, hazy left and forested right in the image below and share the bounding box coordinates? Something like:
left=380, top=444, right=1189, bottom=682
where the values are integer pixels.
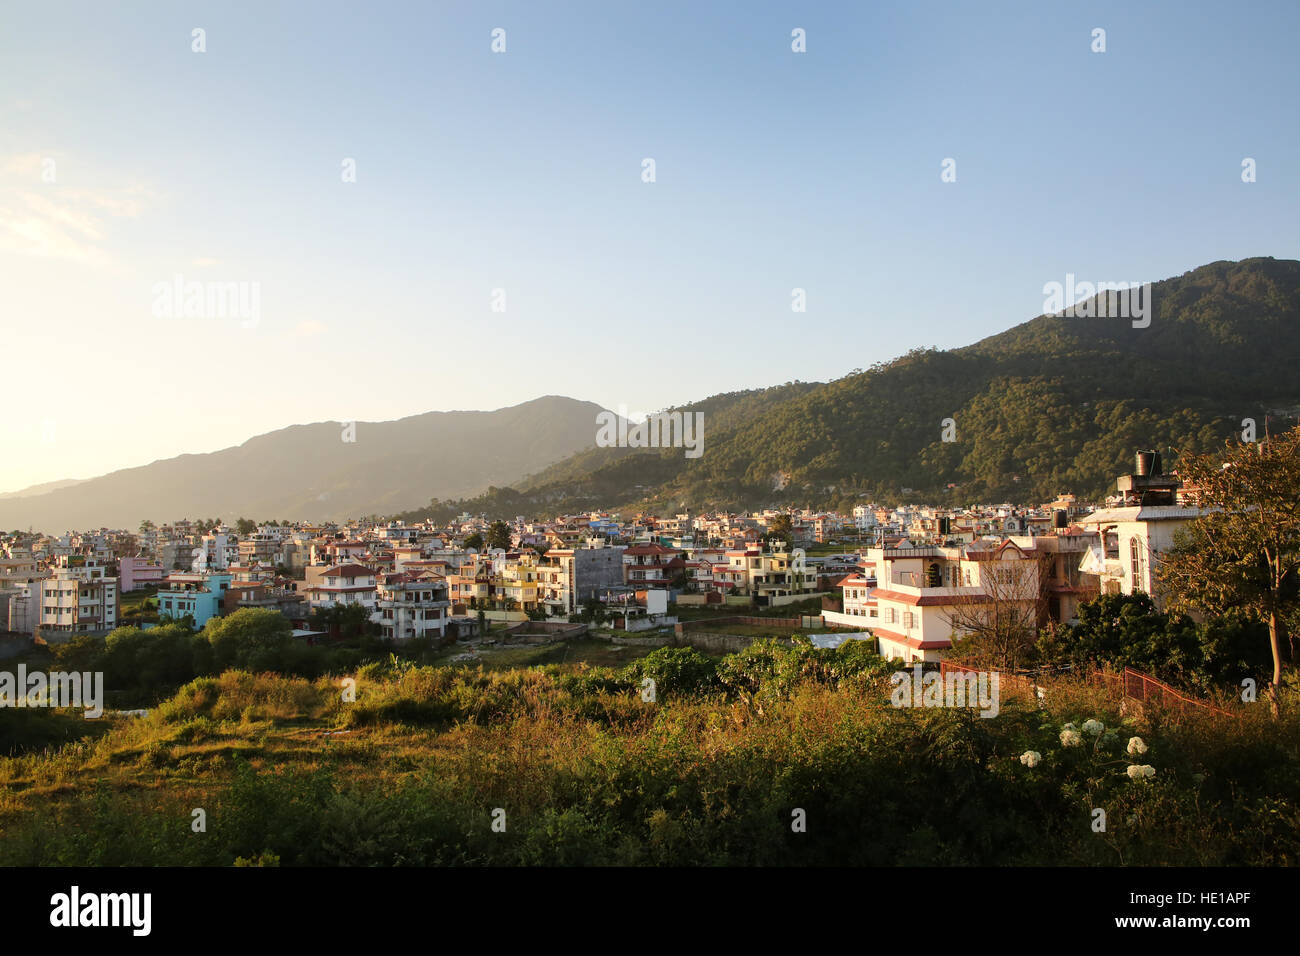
left=0, top=258, right=1300, bottom=532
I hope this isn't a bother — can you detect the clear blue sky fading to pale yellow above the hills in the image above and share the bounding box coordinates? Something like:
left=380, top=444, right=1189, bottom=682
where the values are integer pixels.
left=0, top=0, right=1300, bottom=492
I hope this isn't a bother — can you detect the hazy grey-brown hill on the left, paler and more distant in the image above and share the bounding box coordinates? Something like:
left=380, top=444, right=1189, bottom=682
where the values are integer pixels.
left=0, top=395, right=601, bottom=533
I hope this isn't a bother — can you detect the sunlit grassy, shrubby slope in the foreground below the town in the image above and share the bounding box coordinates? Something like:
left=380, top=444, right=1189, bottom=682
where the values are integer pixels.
left=0, top=643, right=1300, bottom=866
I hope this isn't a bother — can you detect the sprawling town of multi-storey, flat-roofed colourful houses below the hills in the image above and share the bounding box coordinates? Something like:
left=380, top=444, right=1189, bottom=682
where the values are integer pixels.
left=0, top=451, right=1201, bottom=662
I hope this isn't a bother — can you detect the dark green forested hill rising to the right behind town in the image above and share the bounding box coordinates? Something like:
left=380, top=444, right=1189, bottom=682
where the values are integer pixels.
left=403, top=258, right=1300, bottom=514
